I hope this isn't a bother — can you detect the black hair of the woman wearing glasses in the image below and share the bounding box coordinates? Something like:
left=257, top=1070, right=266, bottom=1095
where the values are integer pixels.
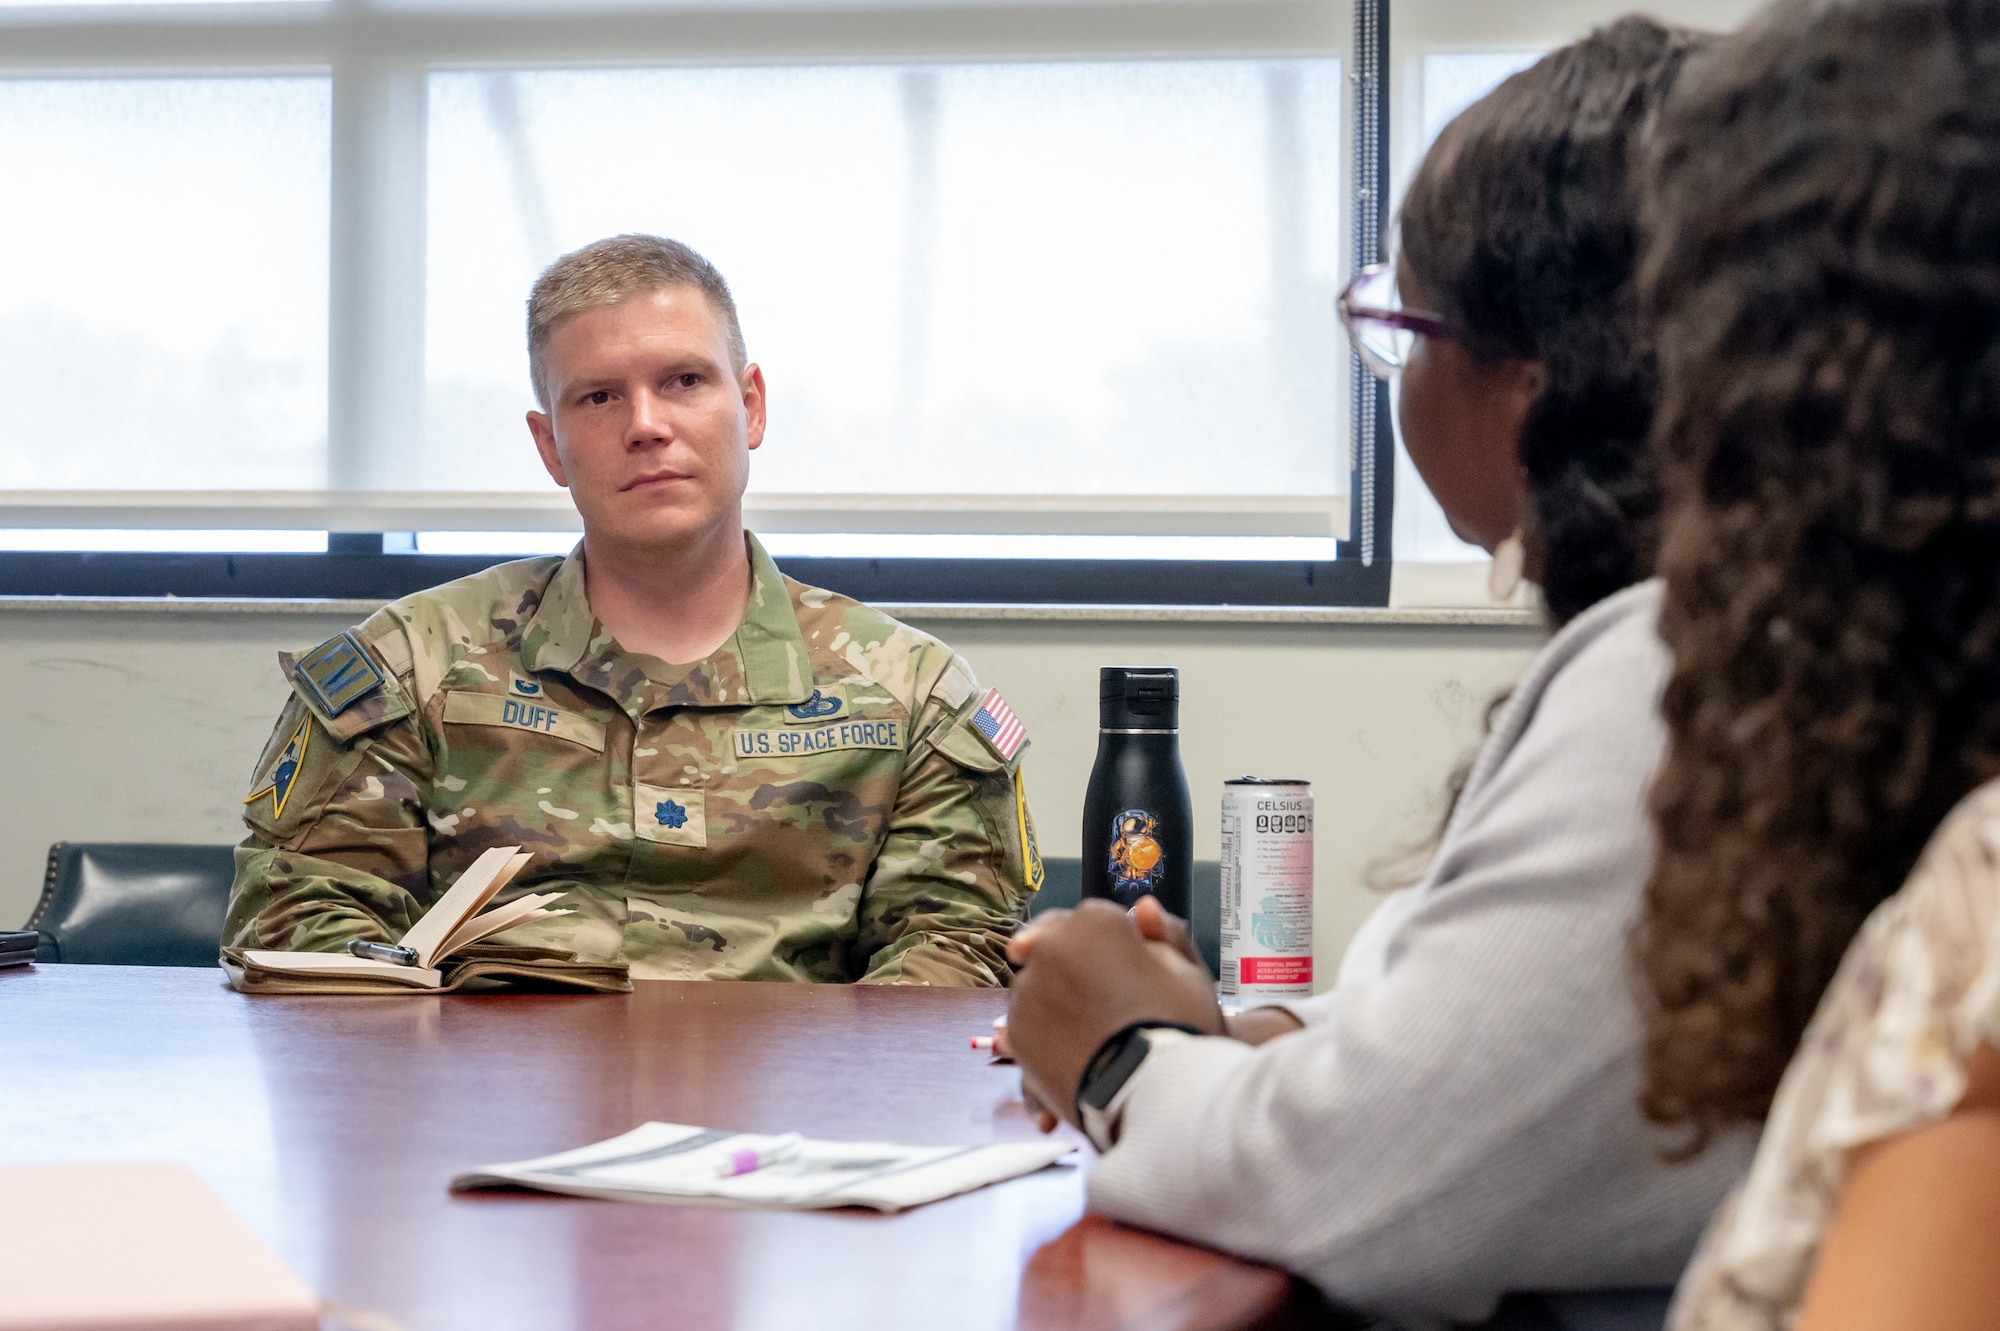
left=1402, top=18, right=1706, bottom=624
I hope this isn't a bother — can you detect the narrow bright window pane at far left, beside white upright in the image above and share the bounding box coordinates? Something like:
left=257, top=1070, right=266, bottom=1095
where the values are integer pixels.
left=0, top=78, right=330, bottom=490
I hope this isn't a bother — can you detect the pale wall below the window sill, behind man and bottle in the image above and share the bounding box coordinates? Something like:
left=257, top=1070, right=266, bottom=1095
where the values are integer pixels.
left=0, top=610, right=1538, bottom=977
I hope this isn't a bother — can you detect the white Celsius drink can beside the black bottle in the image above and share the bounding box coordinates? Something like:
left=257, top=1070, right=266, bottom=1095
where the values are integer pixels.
left=1218, top=777, right=1312, bottom=1003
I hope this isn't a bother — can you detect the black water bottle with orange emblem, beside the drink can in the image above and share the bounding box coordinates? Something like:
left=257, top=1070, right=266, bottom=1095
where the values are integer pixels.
left=1084, top=666, right=1194, bottom=919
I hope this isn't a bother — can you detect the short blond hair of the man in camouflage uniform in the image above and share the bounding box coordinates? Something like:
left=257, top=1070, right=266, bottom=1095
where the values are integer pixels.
left=528, top=236, right=750, bottom=412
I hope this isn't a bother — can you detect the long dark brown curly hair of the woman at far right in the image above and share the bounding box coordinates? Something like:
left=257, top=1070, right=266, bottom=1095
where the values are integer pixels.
left=1634, top=0, right=2000, bottom=1151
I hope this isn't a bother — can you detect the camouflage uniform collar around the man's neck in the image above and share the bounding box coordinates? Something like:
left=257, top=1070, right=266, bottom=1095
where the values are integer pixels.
left=522, top=532, right=812, bottom=715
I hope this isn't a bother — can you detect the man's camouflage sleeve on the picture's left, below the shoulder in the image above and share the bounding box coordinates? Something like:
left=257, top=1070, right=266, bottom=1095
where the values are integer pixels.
left=222, top=635, right=436, bottom=951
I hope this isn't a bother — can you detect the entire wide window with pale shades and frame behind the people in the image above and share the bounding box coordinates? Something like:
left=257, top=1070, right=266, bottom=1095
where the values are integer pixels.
left=0, top=0, right=1748, bottom=602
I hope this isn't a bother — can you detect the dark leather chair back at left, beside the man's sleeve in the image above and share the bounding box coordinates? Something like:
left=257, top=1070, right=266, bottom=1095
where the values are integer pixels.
left=28, top=841, right=236, bottom=965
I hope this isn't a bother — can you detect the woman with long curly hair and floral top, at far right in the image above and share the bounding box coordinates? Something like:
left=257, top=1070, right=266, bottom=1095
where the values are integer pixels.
left=1636, top=0, right=2000, bottom=1331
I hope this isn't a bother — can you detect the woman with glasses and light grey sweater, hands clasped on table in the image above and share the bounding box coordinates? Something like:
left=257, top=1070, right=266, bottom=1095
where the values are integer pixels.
left=1010, top=18, right=1748, bottom=1325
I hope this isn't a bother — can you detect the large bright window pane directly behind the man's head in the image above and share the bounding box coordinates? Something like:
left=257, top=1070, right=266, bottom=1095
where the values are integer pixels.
left=430, top=60, right=1348, bottom=507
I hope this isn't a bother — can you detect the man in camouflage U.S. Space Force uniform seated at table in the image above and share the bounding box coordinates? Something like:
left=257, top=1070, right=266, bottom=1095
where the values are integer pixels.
left=224, top=236, right=1042, bottom=985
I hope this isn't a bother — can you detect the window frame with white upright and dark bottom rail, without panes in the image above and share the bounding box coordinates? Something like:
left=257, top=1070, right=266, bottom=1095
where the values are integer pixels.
left=0, top=0, right=1394, bottom=606
